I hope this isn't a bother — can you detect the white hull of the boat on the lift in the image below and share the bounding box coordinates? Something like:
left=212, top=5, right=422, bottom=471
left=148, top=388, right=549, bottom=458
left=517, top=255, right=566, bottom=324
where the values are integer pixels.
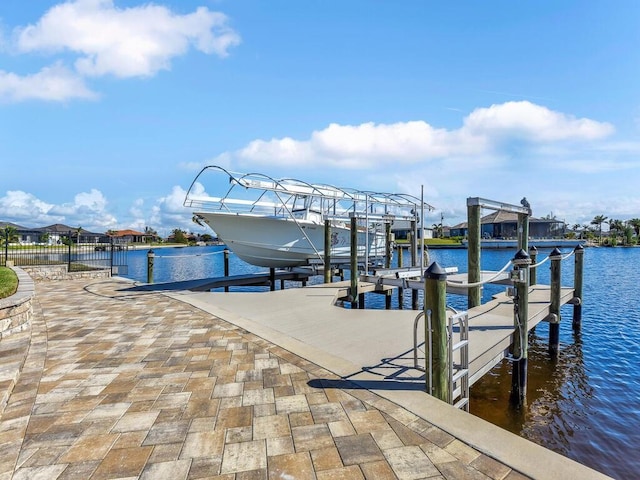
left=196, top=212, right=384, bottom=268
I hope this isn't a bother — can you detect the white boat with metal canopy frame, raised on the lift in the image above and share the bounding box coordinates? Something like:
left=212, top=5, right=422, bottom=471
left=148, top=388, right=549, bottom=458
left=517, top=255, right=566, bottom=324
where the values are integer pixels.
left=184, top=166, right=433, bottom=268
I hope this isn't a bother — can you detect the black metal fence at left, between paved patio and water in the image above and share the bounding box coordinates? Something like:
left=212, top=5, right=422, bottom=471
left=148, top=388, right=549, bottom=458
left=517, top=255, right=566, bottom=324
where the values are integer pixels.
left=0, top=230, right=128, bottom=275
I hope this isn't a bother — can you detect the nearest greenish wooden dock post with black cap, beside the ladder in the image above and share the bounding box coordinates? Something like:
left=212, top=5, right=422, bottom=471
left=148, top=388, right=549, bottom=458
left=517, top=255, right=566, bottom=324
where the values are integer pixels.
left=424, top=262, right=451, bottom=403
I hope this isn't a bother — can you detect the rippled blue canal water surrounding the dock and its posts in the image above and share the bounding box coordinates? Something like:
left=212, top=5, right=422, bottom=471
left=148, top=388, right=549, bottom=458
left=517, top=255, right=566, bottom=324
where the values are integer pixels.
left=128, top=247, right=640, bottom=479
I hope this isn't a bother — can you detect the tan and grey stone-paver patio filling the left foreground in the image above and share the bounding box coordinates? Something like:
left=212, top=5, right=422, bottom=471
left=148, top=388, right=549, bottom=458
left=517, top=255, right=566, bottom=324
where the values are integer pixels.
left=0, top=278, right=603, bottom=480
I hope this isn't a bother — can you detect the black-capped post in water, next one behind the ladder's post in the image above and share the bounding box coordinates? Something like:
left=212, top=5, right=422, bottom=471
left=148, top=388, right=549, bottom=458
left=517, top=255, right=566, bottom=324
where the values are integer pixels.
left=511, top=249, right=531, bottom=407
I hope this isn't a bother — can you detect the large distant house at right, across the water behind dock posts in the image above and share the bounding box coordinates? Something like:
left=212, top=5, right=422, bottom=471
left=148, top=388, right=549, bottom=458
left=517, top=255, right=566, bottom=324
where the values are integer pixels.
left=451, top=210, right=566, bottom=239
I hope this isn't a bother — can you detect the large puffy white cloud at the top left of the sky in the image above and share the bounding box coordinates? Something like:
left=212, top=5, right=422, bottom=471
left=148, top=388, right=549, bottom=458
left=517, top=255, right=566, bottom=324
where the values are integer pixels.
left=14, top=0, right=240, bottom=77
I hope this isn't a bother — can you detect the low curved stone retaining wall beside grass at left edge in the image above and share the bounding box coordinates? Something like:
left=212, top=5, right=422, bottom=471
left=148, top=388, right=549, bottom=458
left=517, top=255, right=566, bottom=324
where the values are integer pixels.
left=0, top=268, right=35, bottom=338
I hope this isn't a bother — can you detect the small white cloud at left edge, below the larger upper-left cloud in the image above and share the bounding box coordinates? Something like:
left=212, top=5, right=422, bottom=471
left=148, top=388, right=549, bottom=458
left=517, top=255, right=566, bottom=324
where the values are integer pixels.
left=0, top=62, right=97, bottom=102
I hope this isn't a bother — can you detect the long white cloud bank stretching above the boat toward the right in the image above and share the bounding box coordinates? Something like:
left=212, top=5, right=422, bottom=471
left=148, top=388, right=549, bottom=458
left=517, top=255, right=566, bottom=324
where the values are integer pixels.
left=219, top=101, right=613, bottom=169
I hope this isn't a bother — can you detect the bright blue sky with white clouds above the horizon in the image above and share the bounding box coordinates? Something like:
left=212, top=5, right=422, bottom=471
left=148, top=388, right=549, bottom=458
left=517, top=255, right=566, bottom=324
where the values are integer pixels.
left=0, top=0, right=640, bottom=235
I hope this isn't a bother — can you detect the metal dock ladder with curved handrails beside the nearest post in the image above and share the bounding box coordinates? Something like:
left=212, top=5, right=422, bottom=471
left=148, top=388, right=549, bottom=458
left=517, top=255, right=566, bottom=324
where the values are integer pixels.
left=413, top=311, right=469, bottom=412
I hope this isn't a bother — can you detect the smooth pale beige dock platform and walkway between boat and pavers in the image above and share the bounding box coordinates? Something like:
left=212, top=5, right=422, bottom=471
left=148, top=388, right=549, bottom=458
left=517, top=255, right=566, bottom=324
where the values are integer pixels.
left=172, top=272, right=573, bottom=390
